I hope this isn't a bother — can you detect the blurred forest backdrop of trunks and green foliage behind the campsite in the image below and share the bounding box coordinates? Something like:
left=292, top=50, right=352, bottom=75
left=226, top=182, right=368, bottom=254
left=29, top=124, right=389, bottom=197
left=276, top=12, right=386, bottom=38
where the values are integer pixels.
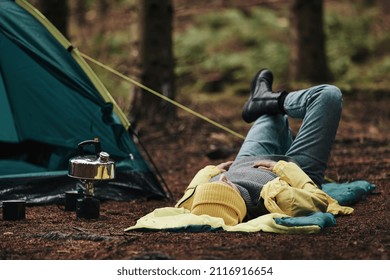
left=32, top=0, right=390, bottom=123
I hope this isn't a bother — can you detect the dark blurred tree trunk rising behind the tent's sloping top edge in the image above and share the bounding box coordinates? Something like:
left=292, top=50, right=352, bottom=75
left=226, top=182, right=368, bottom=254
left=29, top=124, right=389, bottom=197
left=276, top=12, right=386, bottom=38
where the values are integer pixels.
left=37, top=0, right=69, bottom=37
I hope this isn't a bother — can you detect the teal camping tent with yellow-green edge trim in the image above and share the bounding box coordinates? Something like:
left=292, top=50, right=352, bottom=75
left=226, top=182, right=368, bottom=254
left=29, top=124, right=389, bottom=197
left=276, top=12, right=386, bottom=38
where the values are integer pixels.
left=0, top=0, right=167, bottom=203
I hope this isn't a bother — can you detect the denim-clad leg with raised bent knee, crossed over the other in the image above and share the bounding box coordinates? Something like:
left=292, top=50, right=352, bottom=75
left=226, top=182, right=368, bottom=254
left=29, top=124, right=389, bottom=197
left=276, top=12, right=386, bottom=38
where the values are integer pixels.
left=284, top=85, right=342, bottom=186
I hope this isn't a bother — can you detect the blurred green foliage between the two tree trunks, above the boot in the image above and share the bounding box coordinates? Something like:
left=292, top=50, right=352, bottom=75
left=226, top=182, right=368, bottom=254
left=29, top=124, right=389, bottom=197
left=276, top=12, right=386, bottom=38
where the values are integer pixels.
left=174, top=8, right=288, bottom=92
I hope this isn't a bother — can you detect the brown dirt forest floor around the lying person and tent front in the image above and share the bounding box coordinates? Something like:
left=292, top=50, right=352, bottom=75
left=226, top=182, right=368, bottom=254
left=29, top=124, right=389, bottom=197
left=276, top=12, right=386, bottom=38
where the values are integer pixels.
left=0, top=93, right=390, bottom=260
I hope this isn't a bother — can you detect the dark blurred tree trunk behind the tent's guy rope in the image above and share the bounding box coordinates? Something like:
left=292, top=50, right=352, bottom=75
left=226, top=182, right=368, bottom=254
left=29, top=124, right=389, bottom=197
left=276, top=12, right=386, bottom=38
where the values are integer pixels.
left=131, top=0, right=176, bottom=122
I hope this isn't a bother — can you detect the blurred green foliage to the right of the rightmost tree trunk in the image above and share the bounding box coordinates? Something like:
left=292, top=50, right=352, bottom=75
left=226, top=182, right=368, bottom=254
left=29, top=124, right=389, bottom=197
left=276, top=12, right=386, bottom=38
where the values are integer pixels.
left=326, top=7, right=390, bottom=90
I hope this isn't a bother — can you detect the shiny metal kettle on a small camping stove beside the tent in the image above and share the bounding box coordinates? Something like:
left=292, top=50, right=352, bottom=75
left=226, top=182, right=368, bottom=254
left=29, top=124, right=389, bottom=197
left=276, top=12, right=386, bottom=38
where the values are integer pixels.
left=68, top=139, right=115, bottom=219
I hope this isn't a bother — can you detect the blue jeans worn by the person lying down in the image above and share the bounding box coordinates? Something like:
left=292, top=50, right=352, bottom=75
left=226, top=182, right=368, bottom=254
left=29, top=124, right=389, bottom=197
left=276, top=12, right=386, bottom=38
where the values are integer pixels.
left=237, top=85, right=342, bottom=186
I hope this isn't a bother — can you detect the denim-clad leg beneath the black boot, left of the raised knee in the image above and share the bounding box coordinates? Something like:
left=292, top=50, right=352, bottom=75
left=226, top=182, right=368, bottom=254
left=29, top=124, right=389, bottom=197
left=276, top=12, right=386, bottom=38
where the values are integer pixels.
left=237, top=115, right=292, bottom=158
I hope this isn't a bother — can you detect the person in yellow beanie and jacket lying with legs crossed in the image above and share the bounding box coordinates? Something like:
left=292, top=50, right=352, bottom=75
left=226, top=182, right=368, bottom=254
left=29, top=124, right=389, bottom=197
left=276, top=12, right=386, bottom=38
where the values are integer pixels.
left=175, top=69, right=353, bottom=226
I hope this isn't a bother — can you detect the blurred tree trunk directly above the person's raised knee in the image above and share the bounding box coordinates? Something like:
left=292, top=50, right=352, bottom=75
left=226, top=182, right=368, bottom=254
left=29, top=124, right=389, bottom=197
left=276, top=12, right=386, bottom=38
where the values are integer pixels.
left=290, top=0, right=331, bottom=82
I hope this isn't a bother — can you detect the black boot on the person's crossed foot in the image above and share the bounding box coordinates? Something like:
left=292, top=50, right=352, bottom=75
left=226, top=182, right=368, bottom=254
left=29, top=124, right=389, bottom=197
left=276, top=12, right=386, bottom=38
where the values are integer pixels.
left=242, top=69, right=287, bottom=123
